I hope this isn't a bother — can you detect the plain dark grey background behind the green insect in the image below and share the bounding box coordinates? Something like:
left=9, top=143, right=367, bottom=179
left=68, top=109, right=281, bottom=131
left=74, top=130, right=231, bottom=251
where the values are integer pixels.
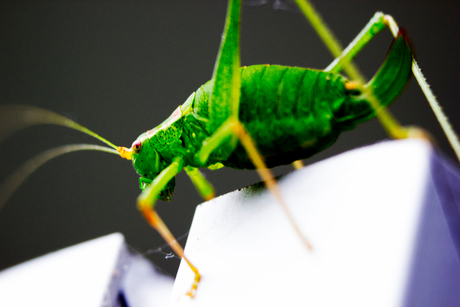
left=0, top=0, right=460, bottom=280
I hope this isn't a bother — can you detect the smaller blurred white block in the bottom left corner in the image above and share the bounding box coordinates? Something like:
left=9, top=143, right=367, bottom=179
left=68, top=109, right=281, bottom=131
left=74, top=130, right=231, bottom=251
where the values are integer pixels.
left=0, top=233, right=124, bottom=307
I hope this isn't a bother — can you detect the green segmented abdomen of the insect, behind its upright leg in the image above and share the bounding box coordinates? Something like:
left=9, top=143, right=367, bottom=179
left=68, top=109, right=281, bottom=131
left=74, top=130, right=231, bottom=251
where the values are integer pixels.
left=222, top=65, right=346, bottom=169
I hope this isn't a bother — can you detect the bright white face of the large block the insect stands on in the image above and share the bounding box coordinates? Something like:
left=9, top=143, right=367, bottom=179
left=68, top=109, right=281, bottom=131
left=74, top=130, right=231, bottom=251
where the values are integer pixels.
left=171, top=140, right=432, bottom=306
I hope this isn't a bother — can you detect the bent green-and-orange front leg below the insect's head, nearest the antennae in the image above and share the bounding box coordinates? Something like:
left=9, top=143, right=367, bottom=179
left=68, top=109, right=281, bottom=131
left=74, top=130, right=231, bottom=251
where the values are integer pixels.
left=137, top=157, right=201, bottom=297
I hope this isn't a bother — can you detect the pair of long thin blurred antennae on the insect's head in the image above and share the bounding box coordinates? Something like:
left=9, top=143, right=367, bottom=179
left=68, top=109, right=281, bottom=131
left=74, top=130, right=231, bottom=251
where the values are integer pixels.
left=0, top=105, right=120, bottom=210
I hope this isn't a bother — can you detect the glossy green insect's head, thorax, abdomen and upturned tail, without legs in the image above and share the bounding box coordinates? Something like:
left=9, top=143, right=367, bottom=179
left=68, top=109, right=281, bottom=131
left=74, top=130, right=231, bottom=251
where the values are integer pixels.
left=133, top=29, right=412, bottom=183
